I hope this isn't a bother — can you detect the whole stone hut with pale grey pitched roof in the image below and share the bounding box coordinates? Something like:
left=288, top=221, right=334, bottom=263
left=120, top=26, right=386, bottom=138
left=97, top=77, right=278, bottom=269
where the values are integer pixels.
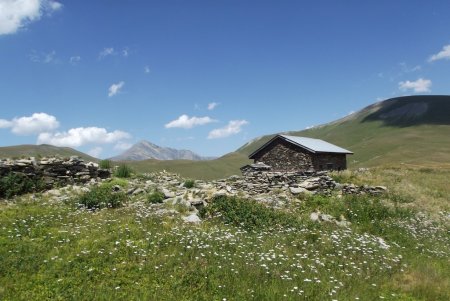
left=241, top=135, right=353, bottom=173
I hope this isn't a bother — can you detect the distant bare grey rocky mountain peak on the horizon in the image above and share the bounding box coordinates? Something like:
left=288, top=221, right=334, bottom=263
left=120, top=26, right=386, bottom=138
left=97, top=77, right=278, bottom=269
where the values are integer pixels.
left=111, top=140, right=213, bottom=161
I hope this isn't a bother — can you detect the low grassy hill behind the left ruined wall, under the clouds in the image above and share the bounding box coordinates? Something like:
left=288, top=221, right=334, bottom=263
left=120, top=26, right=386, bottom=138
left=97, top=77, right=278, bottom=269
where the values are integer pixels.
left=0, top=144, right=98, bottom=162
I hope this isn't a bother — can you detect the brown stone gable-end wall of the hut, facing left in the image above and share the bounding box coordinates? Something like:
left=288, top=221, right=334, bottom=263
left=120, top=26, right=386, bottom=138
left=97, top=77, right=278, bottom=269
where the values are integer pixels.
left=254, top=139, right=313, bottom=171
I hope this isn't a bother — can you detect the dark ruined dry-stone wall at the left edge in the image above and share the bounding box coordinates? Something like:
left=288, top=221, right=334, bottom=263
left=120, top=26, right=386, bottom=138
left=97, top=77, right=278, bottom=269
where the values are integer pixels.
left=0, top=156, right=111, bottom=187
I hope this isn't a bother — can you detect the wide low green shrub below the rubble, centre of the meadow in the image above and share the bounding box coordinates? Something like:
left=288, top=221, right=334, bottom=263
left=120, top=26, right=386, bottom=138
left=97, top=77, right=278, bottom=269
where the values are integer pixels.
left=200, top=196, right=300, bottom=230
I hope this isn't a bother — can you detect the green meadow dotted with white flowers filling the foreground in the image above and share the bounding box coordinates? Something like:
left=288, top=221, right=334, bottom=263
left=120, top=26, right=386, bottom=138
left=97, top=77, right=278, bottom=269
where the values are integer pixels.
left=0, top=169, right=450, bottom=301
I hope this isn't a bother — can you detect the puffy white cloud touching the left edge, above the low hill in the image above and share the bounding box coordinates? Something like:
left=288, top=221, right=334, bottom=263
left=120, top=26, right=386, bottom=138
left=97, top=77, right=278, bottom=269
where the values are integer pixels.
left=0, top=113, right=59, bottom=135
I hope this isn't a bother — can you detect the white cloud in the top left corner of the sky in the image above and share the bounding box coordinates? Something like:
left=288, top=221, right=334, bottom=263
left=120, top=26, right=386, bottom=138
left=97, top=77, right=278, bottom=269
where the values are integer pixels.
left=0, top=0, right=62, bottom=35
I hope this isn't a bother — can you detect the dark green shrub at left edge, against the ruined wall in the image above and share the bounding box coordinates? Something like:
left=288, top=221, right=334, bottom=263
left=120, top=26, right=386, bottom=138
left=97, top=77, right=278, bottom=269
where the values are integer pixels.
left=0, top=172, right=45, bottom=199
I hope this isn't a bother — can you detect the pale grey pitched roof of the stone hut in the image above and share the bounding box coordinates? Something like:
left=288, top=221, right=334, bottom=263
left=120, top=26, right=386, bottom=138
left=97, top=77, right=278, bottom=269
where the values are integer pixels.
left=249, top=135, right=353, bottom=159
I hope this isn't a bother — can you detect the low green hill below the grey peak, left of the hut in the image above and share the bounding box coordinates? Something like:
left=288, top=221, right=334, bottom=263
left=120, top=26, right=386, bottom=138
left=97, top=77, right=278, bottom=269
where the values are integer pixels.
left=126, top=153, right=252, bottom=180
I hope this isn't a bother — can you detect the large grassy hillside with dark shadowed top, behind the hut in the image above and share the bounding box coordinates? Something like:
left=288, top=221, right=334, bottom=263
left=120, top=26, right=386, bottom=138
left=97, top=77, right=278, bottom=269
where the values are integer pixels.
left=238, top=96, right=450, bottom=168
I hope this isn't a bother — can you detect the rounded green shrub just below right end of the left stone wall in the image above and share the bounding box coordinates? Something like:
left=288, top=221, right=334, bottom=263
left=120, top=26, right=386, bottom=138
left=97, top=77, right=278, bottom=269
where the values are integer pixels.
left=78, top=183, right=127, bottom=209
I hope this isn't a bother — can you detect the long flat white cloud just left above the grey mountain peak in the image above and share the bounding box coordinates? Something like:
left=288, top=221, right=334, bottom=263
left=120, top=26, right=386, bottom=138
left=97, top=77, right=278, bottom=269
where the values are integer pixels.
left=37, top=127, right=131, bottom=147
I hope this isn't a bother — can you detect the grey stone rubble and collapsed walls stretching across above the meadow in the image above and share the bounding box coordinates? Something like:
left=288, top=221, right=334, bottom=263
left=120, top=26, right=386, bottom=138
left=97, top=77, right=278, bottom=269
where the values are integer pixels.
left=0, top=157, right=386, bottom=226
